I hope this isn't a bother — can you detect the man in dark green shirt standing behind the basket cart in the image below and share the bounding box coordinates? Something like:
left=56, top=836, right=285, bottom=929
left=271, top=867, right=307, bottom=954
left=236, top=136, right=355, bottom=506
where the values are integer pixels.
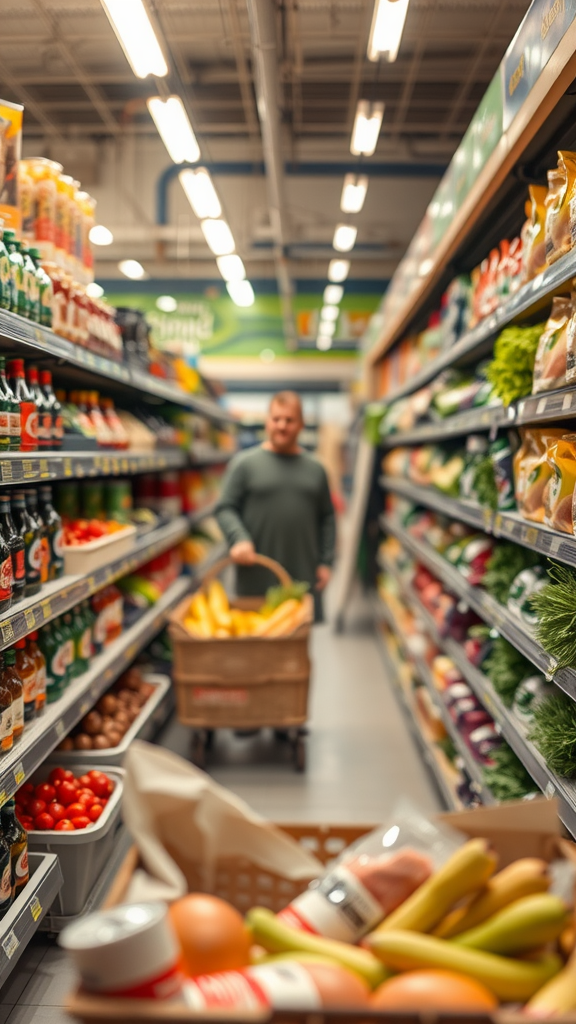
left=216, top=391, right=335, bottom=622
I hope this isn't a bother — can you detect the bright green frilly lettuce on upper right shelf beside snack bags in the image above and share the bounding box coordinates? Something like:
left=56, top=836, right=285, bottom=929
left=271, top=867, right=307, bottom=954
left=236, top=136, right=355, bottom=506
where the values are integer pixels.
left=486, top=324, right=545, bottom=406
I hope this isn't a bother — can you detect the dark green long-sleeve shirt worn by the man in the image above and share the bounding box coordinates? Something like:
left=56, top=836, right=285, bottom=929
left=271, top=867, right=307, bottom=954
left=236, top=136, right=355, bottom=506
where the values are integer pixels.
left=216, top=447, right=335, bottom=596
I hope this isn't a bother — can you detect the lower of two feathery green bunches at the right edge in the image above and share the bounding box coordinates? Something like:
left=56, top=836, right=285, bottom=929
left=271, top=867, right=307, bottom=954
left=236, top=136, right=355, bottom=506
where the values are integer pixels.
left=529, top=690, right=576, bottom=778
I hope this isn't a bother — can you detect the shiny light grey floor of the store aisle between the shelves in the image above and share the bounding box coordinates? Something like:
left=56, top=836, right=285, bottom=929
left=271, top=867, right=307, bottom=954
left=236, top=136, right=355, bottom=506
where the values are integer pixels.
left=0, top=598, right=440, bottom=1024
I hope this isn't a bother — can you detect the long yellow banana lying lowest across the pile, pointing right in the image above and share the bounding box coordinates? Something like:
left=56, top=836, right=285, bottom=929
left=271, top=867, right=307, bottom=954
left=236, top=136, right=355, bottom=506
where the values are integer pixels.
left=365, top=931, right=562, bottom=1002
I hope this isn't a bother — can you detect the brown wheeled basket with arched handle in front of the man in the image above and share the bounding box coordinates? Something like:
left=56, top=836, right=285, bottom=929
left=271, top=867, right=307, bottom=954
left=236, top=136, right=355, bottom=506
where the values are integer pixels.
left=169, top=555, right=314, bottom=771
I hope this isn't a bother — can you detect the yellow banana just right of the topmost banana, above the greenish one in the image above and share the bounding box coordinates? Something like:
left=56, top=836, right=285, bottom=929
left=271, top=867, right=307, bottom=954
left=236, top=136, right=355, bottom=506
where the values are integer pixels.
left=434, top=857, right=550, bottom=939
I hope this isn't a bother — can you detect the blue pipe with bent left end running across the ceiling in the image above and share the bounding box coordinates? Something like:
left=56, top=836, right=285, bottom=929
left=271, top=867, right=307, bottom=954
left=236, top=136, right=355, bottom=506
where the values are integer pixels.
left=156, top=160, right=446, bottom=224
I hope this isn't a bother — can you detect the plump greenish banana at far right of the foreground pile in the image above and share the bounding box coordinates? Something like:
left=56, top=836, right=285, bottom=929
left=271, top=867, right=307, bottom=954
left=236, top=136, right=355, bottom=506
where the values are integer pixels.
left=450, top=893, right=570, bottom=955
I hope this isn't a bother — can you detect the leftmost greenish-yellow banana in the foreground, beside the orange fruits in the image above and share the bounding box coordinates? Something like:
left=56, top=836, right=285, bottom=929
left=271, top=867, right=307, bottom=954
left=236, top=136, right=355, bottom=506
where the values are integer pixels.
left=246, top=906, right=387, bottom=988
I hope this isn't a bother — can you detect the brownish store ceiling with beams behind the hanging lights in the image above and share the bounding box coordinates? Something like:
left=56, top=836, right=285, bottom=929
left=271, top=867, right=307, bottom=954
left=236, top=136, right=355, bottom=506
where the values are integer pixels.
left=0, top=0, right=529, bottom=279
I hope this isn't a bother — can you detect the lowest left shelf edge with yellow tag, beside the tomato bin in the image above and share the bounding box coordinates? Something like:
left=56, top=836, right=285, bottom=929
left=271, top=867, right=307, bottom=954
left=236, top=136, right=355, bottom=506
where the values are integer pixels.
left=0, top=853, right=63, bottom=986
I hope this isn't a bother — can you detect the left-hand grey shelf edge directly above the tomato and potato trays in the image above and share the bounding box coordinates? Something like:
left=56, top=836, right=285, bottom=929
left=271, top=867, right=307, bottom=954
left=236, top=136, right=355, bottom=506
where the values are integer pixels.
left=0, top=577, right=190, bottom=805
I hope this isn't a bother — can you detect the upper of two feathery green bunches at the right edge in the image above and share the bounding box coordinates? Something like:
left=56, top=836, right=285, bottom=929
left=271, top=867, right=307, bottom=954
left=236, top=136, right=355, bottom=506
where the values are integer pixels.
left=530, top=564, right=576, bottom=669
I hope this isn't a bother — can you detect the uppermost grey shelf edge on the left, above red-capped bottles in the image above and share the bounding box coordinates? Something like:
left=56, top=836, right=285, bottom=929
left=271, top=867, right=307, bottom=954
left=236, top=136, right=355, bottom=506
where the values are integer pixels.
left=0, top=309, right=235, bottom=423
